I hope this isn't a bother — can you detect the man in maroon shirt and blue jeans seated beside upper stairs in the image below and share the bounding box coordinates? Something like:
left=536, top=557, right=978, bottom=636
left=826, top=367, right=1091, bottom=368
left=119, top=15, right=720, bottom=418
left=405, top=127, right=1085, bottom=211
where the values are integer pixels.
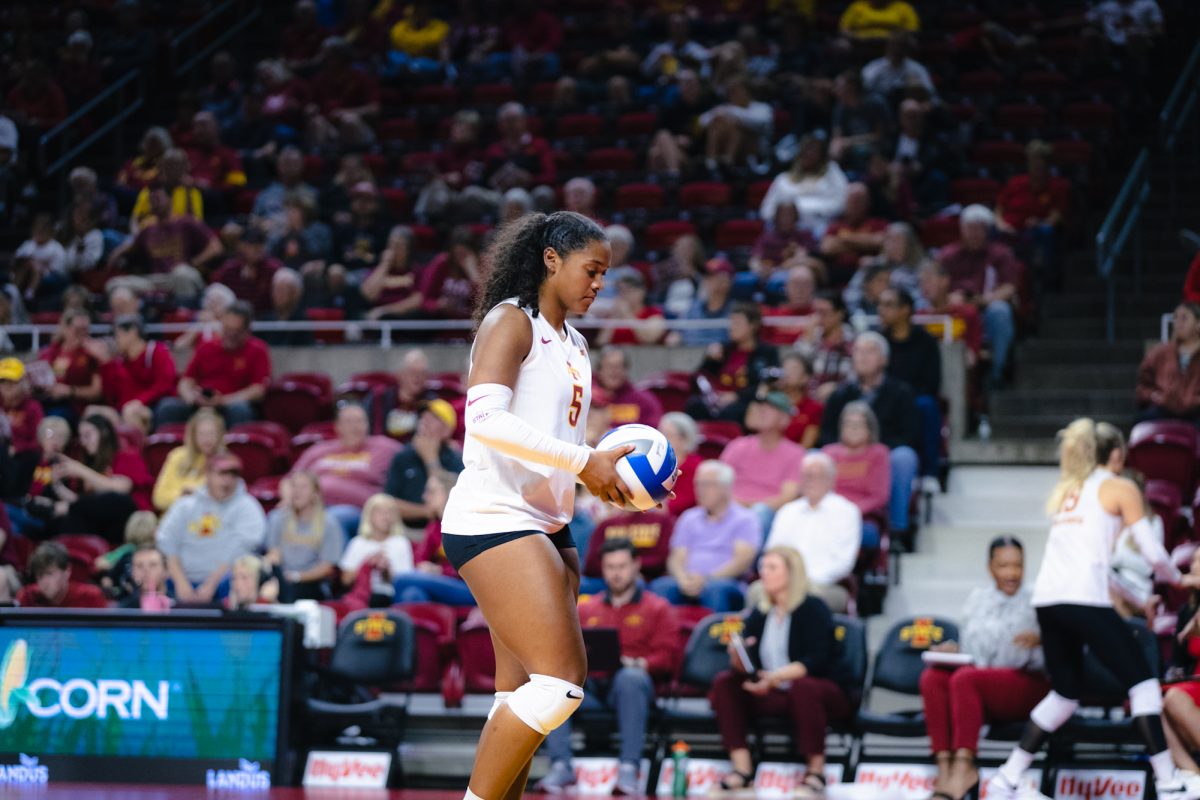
left=937, top=204, right=1024, bottom=389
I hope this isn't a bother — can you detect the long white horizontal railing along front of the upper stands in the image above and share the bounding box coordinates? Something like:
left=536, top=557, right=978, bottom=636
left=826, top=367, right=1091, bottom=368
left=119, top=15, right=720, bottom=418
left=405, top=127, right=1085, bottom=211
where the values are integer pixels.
left=0, top=314, right=954, bottom=351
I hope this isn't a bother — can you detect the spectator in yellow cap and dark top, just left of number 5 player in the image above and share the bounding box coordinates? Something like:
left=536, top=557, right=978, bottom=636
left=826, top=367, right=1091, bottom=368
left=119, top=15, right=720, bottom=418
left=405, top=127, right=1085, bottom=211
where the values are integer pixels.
left=384, top=399, right=462, bottom=527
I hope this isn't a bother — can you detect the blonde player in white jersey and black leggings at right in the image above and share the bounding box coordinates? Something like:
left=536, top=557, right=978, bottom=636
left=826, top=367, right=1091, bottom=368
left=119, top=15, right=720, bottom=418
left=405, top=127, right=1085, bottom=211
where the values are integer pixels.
left=988, top=419, right=1200, bottom=800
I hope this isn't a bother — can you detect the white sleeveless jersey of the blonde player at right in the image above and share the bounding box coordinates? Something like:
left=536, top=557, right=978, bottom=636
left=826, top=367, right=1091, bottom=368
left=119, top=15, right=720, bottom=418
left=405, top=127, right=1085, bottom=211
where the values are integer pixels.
left=1033, top=467, right=1123, bottom=606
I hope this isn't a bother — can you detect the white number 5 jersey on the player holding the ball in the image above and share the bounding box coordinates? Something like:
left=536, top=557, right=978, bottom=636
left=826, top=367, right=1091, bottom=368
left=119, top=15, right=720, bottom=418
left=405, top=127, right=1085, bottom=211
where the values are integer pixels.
left=442, top=299, right=592, bottom=536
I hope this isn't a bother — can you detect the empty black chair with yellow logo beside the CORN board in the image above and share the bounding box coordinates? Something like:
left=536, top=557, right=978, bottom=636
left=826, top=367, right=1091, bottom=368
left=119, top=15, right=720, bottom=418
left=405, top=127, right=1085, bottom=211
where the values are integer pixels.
left=306, top=608, right=416, bottom=762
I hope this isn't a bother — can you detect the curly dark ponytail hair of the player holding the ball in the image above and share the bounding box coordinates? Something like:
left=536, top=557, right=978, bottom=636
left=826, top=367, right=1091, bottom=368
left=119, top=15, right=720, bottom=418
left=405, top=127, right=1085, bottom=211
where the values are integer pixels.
left=475, top=211, right=606, bottom=330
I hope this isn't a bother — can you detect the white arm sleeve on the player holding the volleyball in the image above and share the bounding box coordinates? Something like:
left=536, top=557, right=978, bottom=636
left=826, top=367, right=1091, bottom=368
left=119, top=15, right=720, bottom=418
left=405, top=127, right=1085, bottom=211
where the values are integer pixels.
left=467, top=384, right=592, bottom=475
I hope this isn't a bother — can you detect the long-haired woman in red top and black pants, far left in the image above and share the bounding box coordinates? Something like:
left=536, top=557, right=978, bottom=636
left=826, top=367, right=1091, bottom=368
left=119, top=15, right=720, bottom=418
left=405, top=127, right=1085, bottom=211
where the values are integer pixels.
left=50, top=414, right=154, bottom=547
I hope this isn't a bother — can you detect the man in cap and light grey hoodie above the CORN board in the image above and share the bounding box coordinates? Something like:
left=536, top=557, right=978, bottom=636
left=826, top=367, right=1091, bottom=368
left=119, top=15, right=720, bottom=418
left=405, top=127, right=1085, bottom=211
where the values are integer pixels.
left=158, top=453, right=266, bottom=603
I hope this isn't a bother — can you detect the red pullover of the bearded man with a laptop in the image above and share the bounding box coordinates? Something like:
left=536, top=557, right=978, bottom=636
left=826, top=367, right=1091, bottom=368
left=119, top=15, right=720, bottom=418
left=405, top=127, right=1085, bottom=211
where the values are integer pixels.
left=580, top=589, right=679, bottom=675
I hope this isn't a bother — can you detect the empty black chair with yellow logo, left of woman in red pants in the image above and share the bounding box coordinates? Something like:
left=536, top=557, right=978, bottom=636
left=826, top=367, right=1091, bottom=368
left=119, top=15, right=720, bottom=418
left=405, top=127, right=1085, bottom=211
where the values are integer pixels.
left=856, top=616, right=959, bottom=754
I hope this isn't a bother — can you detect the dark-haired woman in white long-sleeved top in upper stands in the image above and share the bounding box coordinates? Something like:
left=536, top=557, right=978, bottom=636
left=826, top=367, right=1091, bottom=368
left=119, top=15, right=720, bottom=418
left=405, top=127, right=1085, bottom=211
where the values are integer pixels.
left=758, top=133, right=850, bottom=236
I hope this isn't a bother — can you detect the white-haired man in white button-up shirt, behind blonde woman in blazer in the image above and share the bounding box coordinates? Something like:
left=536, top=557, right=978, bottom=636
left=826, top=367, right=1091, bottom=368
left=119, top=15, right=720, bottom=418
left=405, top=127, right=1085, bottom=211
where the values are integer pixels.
left=767, top=452, right=863, bottom=612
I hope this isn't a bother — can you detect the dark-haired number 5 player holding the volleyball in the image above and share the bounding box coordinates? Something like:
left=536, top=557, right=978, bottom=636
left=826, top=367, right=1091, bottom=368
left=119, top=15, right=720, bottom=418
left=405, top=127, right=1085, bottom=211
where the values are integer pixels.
left=442, top=211, right=634, bottom=800
